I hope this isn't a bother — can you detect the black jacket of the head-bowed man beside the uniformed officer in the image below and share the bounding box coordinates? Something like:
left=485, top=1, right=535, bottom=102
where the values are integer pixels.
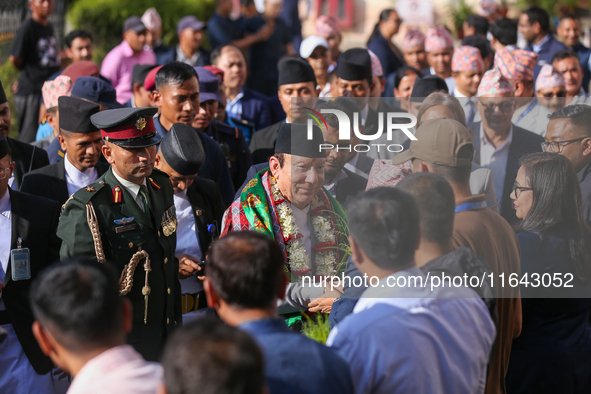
left=187, top=178, right=225, bottom=251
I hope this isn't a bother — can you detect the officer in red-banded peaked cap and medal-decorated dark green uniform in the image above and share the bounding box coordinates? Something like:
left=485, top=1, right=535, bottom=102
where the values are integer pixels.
left=57, top=108, right=181, bottom=360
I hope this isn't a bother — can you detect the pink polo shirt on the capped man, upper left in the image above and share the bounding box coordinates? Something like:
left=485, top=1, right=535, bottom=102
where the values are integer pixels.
left=101, top=40, right=156, bottom=104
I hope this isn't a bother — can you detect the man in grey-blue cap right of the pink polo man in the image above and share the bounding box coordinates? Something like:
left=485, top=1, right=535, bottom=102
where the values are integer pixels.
left=160, top=15, right=209, bottom=67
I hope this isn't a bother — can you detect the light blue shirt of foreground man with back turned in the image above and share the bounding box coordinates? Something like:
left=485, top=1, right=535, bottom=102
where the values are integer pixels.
left=327, top=266, right=496, bottom=394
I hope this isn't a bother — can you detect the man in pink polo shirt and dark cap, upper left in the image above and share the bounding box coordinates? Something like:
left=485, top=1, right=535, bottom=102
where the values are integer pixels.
left=101, top=16, right=156, bottom=104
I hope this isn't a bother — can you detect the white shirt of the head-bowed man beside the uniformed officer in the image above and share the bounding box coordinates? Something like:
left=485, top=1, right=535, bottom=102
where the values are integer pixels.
left=174, top=189, right=203, bottom=294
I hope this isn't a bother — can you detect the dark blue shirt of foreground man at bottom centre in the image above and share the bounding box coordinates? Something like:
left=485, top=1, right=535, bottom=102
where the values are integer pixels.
left=238, top=319, right=354, bottom=394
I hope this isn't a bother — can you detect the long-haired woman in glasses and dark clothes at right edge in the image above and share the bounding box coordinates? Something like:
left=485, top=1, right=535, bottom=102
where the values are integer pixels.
left=505, top=153, right=591, bottom=394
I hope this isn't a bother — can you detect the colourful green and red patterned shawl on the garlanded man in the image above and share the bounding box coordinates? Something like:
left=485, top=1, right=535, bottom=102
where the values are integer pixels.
left=221, top=168, right=350, bottom=281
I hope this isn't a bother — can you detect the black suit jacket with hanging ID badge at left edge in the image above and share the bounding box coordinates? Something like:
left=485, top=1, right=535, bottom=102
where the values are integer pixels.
left=2, top=188, right=60, bottom=375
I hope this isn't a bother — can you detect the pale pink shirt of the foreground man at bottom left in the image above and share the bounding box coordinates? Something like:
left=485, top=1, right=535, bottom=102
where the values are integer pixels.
left=67, top=345, right=163, bottom=394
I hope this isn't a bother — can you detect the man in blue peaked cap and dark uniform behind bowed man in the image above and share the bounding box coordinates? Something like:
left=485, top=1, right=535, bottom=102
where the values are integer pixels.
left=193, top=67, right=252, bottom=189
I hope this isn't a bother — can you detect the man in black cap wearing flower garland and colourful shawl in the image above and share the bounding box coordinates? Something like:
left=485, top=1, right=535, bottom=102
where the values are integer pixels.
left=221, top=123, right=349, bottom=314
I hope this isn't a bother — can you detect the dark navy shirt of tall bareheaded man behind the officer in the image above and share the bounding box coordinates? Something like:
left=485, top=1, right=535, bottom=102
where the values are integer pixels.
left=154, top=117, right=234, bottom=206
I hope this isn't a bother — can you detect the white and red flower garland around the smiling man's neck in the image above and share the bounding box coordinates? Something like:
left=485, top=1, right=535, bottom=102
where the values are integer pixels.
left=270, top=177, right=338, bottom=278
